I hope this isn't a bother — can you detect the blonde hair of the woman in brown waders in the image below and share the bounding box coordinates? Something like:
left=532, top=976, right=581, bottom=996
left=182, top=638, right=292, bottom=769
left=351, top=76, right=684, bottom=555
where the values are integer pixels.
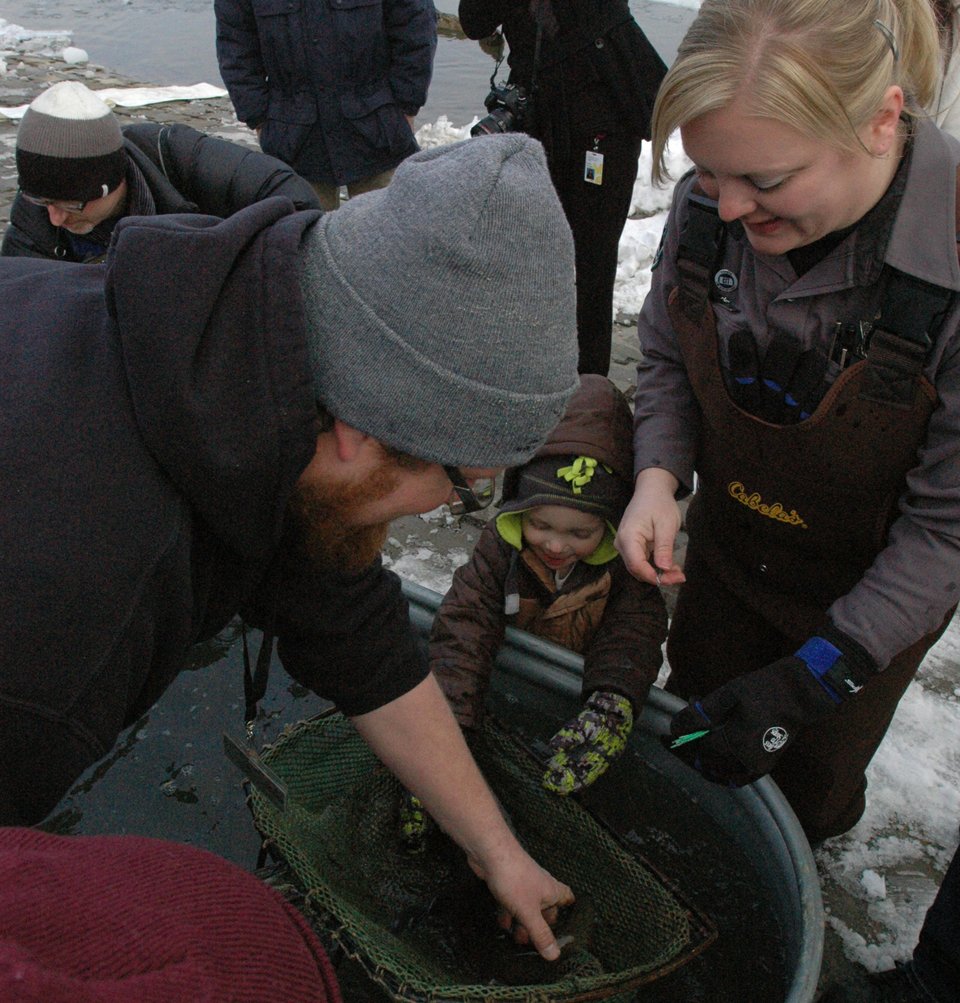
left=652, top=0, right=940, bottom=182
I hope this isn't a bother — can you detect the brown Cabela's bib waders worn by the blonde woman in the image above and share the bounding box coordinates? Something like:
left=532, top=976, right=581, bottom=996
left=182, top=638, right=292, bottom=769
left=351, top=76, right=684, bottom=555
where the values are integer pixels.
left=667, top=195, right=952, bottom=842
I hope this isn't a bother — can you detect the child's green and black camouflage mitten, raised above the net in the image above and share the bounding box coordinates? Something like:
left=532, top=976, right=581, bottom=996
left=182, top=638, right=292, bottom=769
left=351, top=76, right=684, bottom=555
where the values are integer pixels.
left=543, top=690, right=633, bottom=794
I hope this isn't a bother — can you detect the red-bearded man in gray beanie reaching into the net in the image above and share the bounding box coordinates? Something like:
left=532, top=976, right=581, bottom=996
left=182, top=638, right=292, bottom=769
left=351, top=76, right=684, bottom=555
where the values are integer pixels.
left=0, top=135, right=577, bottom=958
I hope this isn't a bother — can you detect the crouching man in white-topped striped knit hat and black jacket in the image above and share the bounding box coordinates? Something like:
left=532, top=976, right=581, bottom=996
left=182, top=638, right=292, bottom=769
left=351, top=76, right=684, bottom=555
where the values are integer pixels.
left=0, top=80, right=318, bottom=263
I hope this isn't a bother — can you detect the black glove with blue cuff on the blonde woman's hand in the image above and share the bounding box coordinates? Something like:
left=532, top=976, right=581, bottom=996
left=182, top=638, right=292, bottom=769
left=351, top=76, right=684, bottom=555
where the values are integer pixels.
left=664, top=624, right=877, bottom=787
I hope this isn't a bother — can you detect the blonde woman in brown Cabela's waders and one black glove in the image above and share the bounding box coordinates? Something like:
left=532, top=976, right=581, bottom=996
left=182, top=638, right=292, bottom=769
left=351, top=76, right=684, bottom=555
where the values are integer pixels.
left=618, top=0, right=960, bottom=842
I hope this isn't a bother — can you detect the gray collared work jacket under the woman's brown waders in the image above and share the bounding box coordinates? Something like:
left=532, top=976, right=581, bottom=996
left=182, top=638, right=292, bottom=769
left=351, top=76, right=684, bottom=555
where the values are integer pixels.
left=634, top=121, right=960, bottom=666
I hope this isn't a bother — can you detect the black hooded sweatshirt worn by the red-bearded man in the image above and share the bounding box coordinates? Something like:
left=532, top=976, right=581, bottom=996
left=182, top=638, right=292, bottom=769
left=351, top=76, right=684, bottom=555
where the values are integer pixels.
left=0, top=199, right=426, bottom=823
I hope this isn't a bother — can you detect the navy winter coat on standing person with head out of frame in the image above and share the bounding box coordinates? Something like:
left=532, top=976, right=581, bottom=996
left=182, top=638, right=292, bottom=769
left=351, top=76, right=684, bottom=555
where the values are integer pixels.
left=214, top=0, right=436, bottom=185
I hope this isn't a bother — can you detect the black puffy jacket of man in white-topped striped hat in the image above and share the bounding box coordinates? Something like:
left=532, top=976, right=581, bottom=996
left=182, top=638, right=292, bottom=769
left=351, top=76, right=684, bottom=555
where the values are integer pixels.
left=0, top=122, right=318, bottom=261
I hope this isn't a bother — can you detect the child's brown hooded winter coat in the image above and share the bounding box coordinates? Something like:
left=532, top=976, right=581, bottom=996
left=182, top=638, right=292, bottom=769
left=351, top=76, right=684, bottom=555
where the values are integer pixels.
left=429, top=376, right=667, bottom=727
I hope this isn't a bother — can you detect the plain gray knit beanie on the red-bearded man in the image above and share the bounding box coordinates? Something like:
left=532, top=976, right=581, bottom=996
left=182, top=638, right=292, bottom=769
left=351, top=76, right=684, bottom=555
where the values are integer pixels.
left=300, top=133, right=578, bottom=467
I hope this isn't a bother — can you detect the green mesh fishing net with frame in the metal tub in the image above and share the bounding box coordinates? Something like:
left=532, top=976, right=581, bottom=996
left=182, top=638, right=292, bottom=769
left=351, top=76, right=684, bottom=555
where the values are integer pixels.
left=251, top=713, right=715, bottom=1003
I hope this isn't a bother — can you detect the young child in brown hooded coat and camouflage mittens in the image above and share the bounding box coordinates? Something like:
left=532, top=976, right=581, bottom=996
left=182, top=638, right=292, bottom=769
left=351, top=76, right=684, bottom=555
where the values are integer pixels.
left=429, top=375, right=667, bottom=794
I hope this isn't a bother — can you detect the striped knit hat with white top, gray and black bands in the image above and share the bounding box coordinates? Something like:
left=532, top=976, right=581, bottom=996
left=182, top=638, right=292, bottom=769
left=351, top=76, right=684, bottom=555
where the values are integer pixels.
left=17, top=80, right=126, bottom=202
